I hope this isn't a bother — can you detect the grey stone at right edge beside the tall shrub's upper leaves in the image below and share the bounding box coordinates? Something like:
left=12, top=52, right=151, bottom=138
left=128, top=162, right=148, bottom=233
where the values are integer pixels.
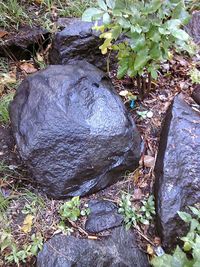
left=185, top=11, right=200, bottom=44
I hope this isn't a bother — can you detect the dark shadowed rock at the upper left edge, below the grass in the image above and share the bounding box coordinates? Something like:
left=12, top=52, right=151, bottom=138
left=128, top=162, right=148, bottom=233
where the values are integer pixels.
left=0, top=26, right=49, bottom=59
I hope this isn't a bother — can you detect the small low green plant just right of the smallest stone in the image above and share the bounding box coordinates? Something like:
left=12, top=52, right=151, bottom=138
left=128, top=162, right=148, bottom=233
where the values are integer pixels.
left=118, top=194, right=155, bottom=229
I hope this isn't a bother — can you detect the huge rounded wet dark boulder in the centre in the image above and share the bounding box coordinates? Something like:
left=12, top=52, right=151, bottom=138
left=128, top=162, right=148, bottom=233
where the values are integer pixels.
left=10, top=62, right=141, bottom=198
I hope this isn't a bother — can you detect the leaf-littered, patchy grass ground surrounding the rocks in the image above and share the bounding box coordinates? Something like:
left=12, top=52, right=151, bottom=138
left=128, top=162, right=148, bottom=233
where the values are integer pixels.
left=0, top=0, right=197, bottom=266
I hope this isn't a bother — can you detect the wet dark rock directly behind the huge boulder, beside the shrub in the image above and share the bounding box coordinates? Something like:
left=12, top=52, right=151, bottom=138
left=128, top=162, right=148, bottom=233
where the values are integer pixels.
left=49, top=18, right=106, bottom=70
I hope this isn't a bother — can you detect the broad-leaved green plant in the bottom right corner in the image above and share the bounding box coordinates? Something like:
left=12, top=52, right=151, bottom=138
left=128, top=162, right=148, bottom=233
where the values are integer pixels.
left=151, top=207, right=200, bottom=267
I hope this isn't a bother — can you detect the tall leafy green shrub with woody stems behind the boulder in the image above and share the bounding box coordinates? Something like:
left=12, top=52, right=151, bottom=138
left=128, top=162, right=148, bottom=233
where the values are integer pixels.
left=82, top=0, right=194, bottom=98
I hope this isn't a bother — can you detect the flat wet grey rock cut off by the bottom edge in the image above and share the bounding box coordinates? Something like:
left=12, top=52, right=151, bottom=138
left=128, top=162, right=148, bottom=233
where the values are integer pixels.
left=37, top=227, right=150, bottom=267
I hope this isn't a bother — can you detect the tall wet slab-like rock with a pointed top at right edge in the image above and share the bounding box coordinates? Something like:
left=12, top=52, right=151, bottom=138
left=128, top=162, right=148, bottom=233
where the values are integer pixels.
left=155, top=94, right=200, bottom=251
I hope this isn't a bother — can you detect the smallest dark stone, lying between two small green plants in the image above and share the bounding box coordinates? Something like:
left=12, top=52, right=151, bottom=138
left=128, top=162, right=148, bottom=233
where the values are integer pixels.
left=85, top=200, right=123, bottom=233
